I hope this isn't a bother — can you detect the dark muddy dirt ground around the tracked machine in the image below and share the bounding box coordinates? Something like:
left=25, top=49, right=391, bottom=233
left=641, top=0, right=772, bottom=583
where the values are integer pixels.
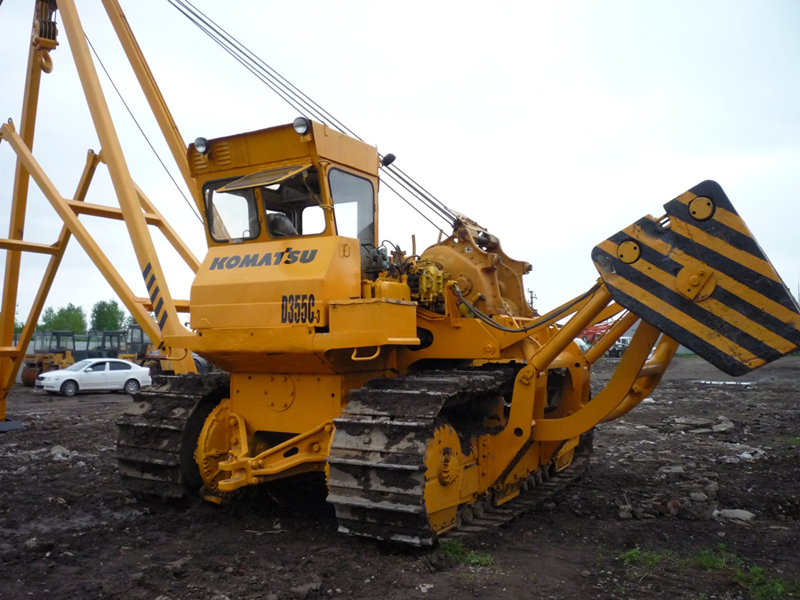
left=0, top=356, right=800, bottom=600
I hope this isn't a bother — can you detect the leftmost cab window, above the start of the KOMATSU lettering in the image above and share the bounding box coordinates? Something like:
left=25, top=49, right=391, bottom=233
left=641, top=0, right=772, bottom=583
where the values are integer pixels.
left=203, top=181, right=261, bottom=242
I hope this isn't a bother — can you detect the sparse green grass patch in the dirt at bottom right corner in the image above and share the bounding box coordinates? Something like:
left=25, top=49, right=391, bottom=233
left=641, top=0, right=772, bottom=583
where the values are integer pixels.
left=620, top=544, right=800, bottom=600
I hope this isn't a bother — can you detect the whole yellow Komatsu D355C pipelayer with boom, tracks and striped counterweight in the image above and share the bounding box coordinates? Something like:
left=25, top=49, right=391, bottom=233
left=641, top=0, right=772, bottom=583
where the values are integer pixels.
left=0, top=0, right=800, bottom=545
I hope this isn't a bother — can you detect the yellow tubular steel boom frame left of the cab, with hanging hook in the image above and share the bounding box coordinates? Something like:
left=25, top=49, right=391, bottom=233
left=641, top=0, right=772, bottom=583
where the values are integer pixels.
left=0, top=0, right=202, bottom=422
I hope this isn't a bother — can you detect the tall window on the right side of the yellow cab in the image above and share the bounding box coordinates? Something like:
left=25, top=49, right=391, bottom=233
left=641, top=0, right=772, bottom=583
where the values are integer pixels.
left=328, top=169, right=375, bottom=246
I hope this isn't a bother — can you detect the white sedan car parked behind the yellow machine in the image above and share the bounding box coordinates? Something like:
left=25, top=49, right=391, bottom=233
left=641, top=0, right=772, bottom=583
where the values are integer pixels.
left=35, top=358, right=152, bottom=396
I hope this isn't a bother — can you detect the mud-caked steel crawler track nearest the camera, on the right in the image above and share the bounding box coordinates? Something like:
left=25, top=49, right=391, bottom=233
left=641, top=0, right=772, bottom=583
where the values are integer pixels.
left=328, top=370, right=588, bottom=546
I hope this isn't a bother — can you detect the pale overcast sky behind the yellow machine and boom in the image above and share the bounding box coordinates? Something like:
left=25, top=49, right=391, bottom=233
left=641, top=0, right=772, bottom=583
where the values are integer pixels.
left=0, top=0, right=800, bottom=326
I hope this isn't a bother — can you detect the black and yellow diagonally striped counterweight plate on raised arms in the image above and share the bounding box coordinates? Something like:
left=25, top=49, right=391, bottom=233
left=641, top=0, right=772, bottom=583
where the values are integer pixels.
left=592, top=181, right=800, bottom=375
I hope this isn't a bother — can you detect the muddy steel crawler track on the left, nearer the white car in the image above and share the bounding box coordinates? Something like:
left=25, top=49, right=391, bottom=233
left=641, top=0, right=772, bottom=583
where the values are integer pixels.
left=116, top=373, right=230, bottom=499
